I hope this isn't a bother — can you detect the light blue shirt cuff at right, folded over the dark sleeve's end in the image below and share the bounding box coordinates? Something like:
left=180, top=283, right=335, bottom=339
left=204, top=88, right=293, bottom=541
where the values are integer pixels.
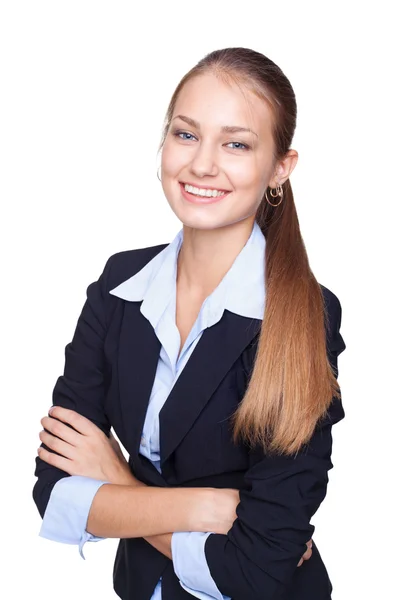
left=171, top=531, right=231, bottom=600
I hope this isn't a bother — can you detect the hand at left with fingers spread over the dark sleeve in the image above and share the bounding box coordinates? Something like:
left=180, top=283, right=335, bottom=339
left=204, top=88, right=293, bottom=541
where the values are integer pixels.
left=38, top=406, right=137, bottom=485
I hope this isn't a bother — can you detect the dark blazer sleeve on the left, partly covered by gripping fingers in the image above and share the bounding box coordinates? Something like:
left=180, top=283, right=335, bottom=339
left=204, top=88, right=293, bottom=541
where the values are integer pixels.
left=32, top=255, right=115, bottom=518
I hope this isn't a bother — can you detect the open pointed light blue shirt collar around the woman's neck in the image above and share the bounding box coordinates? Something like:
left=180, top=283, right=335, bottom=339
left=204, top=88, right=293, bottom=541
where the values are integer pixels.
left=109, top=221, right=266, bottom=326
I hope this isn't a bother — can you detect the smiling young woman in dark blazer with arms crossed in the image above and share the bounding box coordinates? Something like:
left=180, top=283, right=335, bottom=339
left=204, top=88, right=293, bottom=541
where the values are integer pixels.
left=34, top=48, right=345, bottom=600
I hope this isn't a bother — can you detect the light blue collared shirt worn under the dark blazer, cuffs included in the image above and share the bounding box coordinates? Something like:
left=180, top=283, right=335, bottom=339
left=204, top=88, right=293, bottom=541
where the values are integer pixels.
left=39, top=222, right=266, bottom=600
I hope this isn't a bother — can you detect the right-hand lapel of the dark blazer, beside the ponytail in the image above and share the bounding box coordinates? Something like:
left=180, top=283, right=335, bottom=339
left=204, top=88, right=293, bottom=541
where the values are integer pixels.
left=160, top=310, right=261, bottom=467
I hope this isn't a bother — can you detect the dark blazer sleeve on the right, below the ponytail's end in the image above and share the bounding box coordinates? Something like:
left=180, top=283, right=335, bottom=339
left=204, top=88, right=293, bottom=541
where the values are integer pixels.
left=204, top=290, right=346, bottom=600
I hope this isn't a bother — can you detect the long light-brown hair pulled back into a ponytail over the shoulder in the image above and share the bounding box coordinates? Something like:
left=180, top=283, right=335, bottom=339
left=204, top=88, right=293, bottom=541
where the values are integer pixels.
left=160, top=48, right=340, bottom=455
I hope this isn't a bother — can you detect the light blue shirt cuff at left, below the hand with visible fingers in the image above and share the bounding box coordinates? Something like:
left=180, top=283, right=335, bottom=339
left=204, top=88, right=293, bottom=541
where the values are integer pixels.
left=39, top=475, right=109, bottom=559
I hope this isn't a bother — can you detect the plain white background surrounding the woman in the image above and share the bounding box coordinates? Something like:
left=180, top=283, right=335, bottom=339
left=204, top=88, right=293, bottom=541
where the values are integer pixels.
left=0, top=0, right=399, bottom=600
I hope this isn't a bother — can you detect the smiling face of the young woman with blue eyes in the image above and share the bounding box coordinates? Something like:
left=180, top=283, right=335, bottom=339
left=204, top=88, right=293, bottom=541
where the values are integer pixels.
left=161, top=74, right=282, bottom=229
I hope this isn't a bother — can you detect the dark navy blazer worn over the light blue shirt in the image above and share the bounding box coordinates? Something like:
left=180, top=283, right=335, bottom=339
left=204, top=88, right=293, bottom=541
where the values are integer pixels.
left=33, top=244, right=345, bottom=600
